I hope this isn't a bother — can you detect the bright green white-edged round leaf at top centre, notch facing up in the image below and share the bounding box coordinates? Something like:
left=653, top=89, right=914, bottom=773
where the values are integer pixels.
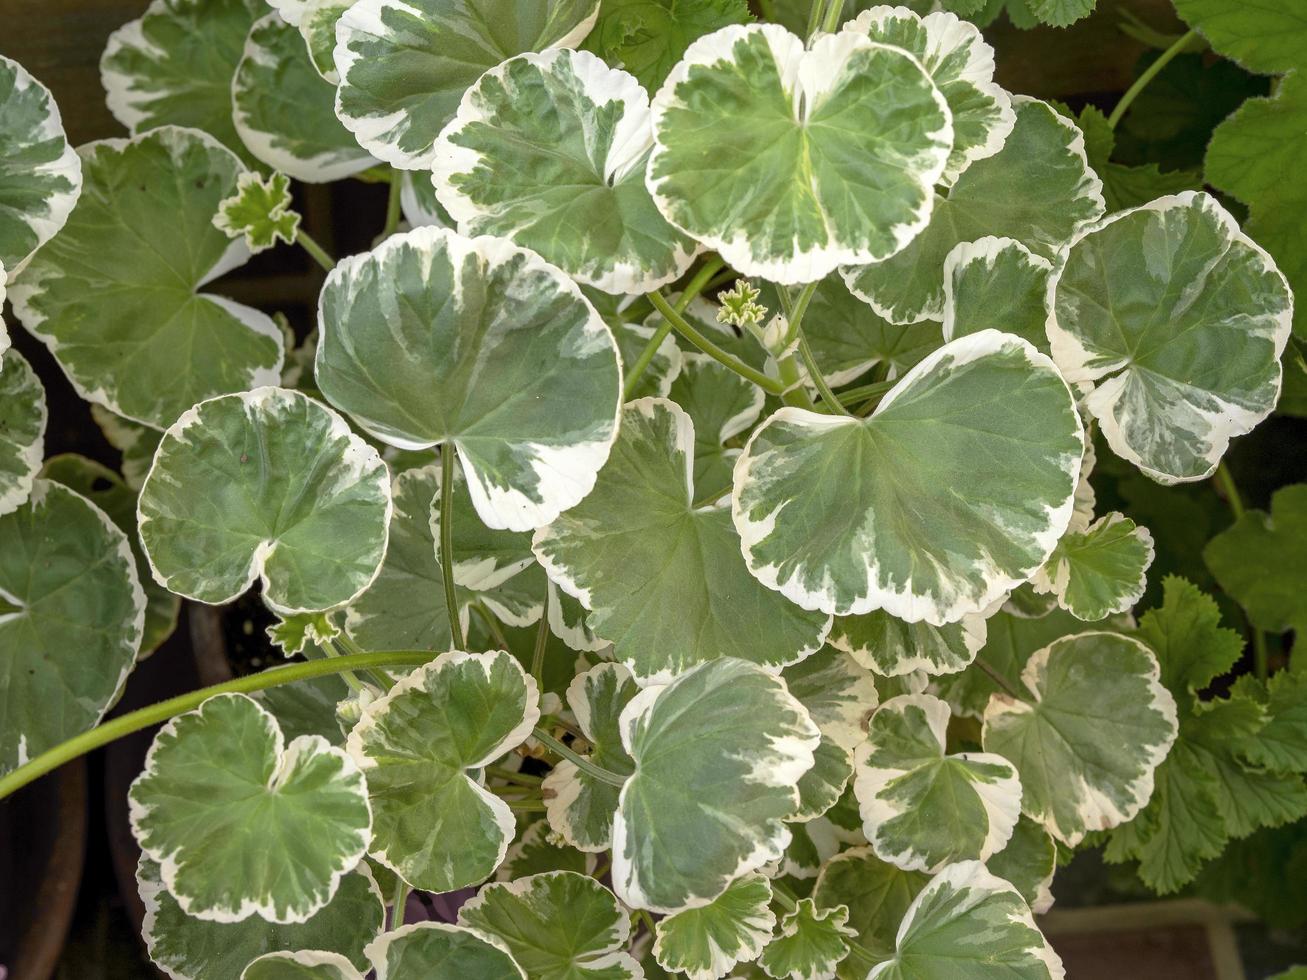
left=648, top=24, right=953, bottom=285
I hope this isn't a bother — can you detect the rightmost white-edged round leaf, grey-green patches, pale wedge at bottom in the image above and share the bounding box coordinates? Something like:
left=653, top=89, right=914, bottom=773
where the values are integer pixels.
left=1047, top=191, right=1293, bottom=485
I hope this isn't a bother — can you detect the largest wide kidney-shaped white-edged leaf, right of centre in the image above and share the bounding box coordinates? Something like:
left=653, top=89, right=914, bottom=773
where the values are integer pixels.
left=732, top=331, right=1084, bottom=626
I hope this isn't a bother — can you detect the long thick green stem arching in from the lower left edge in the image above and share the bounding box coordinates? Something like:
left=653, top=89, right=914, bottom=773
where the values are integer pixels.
left=0, top=649, right=438, bottom=800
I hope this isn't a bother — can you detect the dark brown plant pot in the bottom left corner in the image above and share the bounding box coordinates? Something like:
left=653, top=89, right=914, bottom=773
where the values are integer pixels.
left=0, top=759, right=86, bottom=980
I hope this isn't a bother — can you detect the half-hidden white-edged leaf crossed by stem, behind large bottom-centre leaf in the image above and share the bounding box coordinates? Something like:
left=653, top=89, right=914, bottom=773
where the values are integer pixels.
left=542, top=664, right=640, bottom=852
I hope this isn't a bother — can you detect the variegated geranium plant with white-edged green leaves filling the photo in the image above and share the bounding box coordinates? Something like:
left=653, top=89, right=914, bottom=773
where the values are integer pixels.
left=0, top=0, right=1307, bottom=980
